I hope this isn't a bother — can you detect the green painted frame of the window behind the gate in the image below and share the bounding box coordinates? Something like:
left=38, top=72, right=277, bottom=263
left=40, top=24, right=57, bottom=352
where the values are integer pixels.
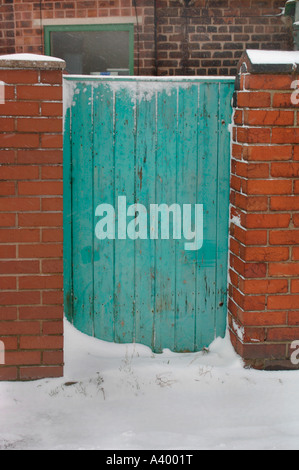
left=44, top=23, right=134, bottom=75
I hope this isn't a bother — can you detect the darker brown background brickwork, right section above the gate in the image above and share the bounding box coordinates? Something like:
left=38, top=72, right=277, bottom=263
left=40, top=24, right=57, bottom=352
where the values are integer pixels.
left=157, top=0, right=292, bottom=75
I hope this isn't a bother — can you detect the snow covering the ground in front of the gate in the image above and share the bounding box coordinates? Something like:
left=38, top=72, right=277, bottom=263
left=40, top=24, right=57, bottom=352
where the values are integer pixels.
left=0, top=322, right=299, bottom=450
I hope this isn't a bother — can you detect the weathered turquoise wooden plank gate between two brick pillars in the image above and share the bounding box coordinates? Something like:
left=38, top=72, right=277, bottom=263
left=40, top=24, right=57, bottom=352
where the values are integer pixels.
left=64, top=76, right=234, bottom=352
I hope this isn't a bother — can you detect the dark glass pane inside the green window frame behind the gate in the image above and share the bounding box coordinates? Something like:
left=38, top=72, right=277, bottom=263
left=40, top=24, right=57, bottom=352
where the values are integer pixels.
left=50, top=31, right=130, bottom=75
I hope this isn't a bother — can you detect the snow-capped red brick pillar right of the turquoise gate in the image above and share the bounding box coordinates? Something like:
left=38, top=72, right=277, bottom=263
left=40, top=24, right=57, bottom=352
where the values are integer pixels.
left=229, top=51, right=299, bottom=369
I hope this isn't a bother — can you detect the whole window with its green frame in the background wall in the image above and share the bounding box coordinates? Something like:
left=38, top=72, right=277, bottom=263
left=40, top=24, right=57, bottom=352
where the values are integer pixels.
left=45, top=24, right=134, bottom=75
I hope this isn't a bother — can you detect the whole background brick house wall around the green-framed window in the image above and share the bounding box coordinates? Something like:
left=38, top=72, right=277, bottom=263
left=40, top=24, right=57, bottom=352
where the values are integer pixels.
left=0, top=0, right=293, bottom=75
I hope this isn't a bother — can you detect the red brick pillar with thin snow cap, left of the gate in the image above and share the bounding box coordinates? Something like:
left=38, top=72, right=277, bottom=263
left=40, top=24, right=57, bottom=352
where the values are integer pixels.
left=0, top=54, right=65, bottom=380
